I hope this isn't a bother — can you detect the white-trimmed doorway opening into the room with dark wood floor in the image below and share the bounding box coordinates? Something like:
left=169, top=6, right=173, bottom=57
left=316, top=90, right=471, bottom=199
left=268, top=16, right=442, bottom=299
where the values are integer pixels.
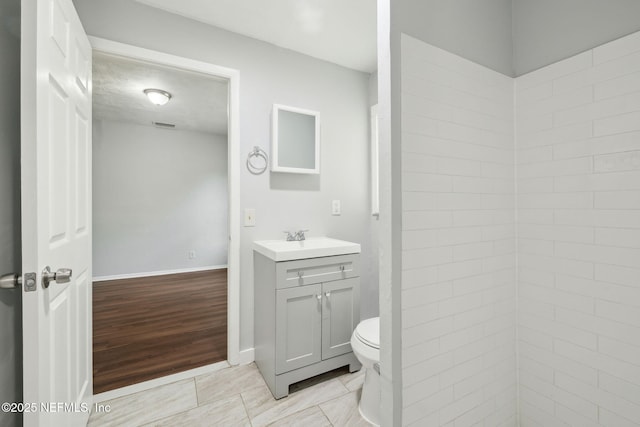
left=91, top=39, right=239, bottom=393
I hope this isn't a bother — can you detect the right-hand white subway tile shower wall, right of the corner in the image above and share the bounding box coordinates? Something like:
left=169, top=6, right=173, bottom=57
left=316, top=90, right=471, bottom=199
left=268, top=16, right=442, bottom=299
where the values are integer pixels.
left=516, top=33, right=640, bottom=427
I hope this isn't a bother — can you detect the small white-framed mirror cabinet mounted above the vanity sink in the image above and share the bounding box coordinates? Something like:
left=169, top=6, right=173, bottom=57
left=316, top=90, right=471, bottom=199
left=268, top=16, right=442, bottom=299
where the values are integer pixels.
left=271, top=104, right=320, bottom=174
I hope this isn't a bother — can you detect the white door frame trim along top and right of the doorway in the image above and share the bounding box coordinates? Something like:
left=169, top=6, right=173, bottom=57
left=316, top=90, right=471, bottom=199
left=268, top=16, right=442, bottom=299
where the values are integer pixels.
left=89, top=36, right=241, bottom=365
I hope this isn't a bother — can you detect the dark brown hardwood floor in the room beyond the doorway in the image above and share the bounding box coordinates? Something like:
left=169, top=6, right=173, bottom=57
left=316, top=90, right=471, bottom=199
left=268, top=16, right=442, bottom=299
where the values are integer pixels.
left=93, top=269, right=227, bottom=393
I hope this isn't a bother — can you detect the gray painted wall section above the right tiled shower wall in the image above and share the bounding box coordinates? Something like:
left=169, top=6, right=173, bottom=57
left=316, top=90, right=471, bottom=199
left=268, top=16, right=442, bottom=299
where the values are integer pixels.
left=513, top=0, right=640, bottom=76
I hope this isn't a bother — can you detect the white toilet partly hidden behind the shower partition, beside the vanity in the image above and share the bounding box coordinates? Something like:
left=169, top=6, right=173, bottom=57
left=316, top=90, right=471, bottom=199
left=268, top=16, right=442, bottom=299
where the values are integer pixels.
left=351, top=317, right=380, bottom=426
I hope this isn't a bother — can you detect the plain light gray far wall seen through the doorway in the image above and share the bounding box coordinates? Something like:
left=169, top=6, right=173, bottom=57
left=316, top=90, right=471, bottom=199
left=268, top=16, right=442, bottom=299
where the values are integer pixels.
left=93, top=120, right=229, bottom=277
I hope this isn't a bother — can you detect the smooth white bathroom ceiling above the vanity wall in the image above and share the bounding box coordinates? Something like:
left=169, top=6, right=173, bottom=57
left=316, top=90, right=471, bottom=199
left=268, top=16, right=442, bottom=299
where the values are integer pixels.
left=136, top=0, right=376, bottom=73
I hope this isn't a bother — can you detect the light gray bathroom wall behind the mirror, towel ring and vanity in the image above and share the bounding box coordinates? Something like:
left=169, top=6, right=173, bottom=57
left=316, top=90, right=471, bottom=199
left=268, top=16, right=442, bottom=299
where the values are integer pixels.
left=75, top=0, right=378, bottom=350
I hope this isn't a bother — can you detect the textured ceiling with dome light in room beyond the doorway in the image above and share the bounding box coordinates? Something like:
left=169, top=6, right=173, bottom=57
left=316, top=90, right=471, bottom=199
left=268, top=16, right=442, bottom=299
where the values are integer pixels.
left=93, top=52, right=228, bottom=135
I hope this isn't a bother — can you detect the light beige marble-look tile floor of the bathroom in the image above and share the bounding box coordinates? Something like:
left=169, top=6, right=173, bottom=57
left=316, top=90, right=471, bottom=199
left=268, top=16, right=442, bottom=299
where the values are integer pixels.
left=88, top=364, right=370, bottom=427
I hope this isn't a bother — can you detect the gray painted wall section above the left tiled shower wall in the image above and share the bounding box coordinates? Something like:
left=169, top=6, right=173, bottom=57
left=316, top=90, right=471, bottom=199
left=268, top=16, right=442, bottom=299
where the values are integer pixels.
left=392, top=0, right=512, bottom=75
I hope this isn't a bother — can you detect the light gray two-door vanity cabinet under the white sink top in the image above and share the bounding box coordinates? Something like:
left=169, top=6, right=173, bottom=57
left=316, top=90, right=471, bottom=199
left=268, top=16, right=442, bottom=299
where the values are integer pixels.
left=254, top=252, right=360, bottom=399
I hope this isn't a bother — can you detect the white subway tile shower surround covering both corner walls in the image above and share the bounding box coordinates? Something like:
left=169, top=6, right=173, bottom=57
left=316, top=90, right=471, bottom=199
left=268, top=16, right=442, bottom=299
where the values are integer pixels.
left=402, top=33, right=640, bottom=427
